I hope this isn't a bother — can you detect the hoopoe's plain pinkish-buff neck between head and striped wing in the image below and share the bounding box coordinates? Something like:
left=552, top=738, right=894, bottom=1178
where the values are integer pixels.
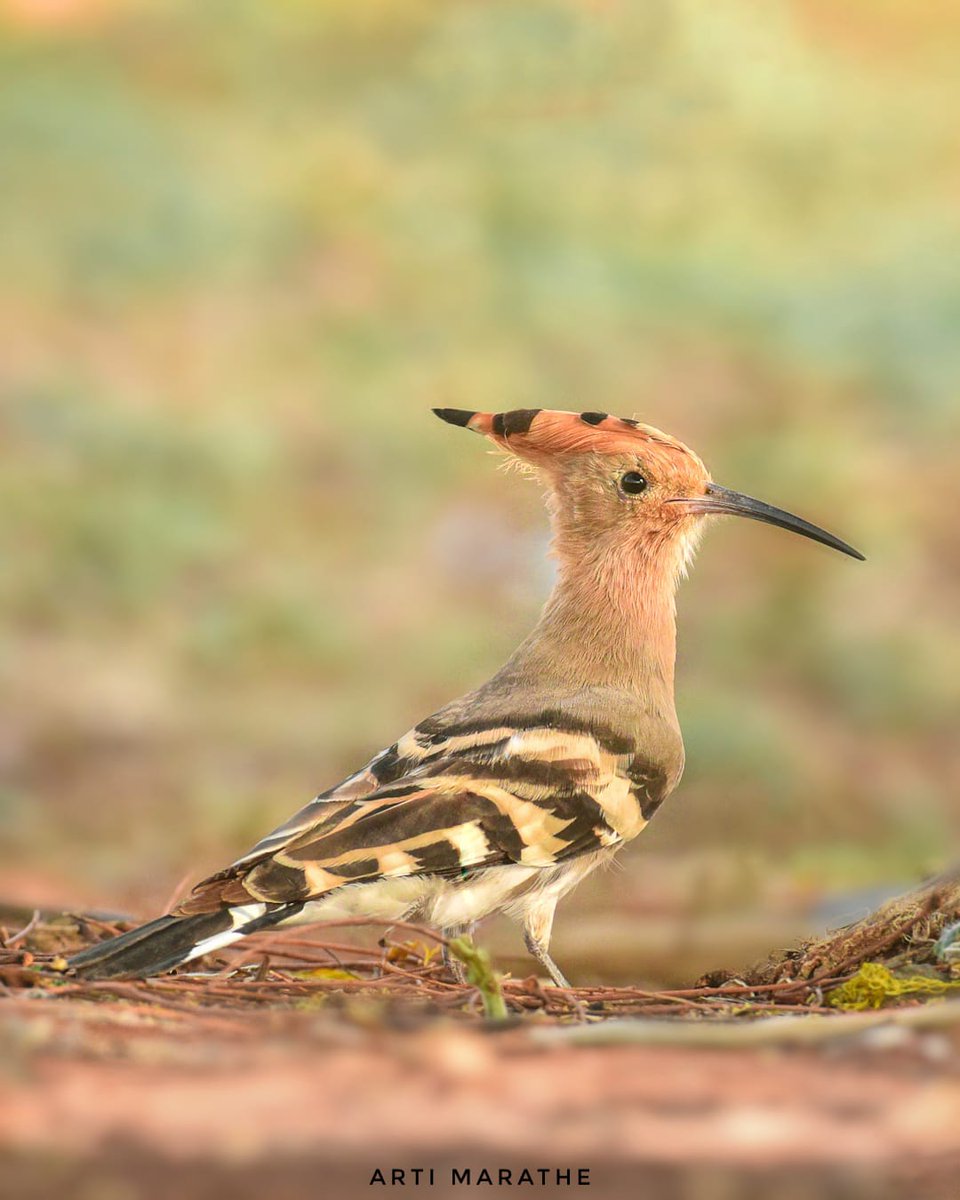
left=505, top=532, right=683, bottom=720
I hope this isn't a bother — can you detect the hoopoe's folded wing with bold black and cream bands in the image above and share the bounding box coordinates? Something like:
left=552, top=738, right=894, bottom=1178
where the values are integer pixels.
left=179, top=721, right=650, bottom=913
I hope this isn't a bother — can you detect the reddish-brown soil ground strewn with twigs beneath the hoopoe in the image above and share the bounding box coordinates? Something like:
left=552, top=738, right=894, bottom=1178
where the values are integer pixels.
left=0, top=888, right=960, bottom=1200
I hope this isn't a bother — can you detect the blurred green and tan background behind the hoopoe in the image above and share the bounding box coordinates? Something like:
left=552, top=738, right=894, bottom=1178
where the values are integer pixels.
left=0, top=0, right=960, bottom=974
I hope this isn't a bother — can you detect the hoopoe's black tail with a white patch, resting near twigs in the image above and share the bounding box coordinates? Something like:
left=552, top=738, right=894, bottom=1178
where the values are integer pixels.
left=67, top=904, right=300, bottom=979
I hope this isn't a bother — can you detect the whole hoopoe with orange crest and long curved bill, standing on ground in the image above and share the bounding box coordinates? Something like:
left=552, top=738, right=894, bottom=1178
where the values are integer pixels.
left=70, top=408, right=863, bottom=986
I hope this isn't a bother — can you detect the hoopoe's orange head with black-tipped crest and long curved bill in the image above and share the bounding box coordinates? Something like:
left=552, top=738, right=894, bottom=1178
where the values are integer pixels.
left=434, top=408, right=863, bottom=563
